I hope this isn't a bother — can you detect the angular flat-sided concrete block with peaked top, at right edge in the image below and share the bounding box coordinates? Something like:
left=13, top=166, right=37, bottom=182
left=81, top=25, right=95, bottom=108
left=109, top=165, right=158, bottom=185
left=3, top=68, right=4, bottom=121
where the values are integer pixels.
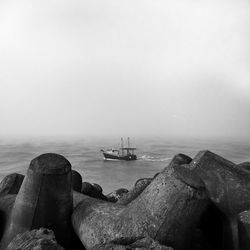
left=190, top=151, right=250, bottom=216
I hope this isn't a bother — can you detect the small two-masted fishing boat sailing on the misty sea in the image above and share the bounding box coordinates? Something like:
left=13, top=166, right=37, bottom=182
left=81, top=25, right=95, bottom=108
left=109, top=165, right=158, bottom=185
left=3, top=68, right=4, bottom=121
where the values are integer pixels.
left=101, top=137, right=137, bottom=161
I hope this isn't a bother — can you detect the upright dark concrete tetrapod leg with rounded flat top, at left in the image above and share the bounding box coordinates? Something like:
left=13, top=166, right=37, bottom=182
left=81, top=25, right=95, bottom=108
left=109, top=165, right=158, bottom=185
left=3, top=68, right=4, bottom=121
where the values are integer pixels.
left=1, top=153, right=73, bottom=249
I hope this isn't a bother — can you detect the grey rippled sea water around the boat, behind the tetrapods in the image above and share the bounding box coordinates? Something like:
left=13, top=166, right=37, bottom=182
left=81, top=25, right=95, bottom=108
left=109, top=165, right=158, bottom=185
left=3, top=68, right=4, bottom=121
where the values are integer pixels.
left=0, top=137, right=250, bottom=194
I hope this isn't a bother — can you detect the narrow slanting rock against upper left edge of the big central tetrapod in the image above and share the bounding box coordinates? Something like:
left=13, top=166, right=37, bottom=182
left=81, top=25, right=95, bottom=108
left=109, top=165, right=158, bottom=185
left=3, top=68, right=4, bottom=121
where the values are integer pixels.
left=117, top=178, right=152, bottom=205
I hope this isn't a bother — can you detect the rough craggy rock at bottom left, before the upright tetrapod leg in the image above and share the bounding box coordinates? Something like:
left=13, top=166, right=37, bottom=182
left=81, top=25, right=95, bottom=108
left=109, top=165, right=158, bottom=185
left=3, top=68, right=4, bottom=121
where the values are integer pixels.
left=6, top=228, right=64, bottom=250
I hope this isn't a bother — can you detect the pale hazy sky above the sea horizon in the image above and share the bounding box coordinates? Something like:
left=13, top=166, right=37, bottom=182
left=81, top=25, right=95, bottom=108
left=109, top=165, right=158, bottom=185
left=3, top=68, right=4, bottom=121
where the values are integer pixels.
left=0, top=0, right=250, bottom=137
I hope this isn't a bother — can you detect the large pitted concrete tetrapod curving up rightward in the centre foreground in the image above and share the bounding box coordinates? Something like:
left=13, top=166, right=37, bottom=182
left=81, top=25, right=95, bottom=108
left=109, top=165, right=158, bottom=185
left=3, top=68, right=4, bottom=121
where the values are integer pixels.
left=72, top=155, right=208, bottom=250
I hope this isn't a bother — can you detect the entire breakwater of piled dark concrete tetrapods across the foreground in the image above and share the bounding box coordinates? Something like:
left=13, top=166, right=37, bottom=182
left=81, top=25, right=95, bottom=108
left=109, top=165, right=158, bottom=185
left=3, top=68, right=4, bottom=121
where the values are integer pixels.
left=0, top=151, right=250, bottom=250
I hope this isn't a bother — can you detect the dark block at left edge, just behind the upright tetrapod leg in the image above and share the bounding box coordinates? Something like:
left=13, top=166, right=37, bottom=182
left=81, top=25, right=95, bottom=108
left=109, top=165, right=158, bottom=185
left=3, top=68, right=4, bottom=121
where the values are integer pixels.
left=0, top=173, right=24, bottom=196
